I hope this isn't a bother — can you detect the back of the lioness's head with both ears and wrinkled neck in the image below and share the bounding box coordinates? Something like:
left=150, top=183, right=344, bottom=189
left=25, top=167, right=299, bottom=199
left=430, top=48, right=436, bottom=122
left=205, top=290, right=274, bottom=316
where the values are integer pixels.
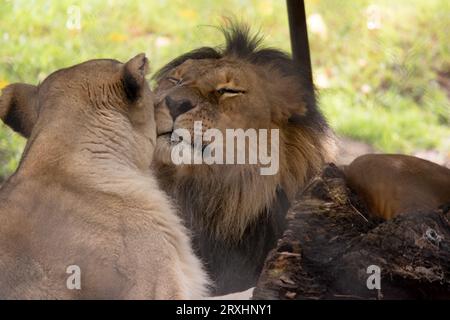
left=0, top=54, right=156, bottom=175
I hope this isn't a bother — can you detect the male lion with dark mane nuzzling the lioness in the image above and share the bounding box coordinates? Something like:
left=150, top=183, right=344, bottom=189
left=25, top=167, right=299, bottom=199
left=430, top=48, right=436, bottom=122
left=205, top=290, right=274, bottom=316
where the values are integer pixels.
left=154, top=26, right=335, bottom=294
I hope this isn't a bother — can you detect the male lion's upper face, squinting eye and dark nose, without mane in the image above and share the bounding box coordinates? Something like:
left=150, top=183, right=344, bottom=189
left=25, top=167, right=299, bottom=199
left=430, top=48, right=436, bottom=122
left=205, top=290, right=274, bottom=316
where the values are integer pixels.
left=156, top=59, right=280, bottom=141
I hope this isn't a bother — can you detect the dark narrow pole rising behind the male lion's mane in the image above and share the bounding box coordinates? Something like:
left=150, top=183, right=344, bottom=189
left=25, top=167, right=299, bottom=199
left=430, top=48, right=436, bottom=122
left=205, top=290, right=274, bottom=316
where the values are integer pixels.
left=286, top=0, right=313, bottom=88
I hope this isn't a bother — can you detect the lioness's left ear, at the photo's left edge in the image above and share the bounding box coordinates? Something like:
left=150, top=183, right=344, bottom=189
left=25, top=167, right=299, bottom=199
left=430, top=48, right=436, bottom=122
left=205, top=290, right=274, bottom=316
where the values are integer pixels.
left=0, top=83, right=38, bottom=138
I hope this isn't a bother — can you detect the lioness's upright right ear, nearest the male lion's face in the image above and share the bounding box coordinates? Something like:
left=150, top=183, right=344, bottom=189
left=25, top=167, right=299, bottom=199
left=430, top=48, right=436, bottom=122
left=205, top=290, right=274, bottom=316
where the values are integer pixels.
left=123, top=53, right=149, bottom=101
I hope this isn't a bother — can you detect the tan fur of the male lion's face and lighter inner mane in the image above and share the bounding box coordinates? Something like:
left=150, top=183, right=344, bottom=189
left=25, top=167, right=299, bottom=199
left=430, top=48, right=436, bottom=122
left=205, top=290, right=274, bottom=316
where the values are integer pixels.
left=154, top=56, right=335, bottom=242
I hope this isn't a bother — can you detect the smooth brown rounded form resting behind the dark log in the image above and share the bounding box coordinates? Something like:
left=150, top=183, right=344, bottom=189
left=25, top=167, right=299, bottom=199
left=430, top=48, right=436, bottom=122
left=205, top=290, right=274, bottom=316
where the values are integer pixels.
left=344, top=154, right=450, bottom=219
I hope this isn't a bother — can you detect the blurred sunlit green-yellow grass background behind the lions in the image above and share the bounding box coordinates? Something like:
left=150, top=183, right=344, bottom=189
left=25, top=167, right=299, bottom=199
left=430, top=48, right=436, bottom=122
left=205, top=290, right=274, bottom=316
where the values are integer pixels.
left=0, top=0, right=450, bottom=180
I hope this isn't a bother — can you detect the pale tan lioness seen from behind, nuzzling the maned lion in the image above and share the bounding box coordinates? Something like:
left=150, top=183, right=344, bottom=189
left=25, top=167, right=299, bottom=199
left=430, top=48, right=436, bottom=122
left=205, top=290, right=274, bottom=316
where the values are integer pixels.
left=0, top=54, right=207, bottom=299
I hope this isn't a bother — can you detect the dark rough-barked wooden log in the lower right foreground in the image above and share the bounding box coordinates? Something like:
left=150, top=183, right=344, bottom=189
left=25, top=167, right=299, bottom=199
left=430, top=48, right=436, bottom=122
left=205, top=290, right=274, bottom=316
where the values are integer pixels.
left=253, top=165, right=450, bottom=299
